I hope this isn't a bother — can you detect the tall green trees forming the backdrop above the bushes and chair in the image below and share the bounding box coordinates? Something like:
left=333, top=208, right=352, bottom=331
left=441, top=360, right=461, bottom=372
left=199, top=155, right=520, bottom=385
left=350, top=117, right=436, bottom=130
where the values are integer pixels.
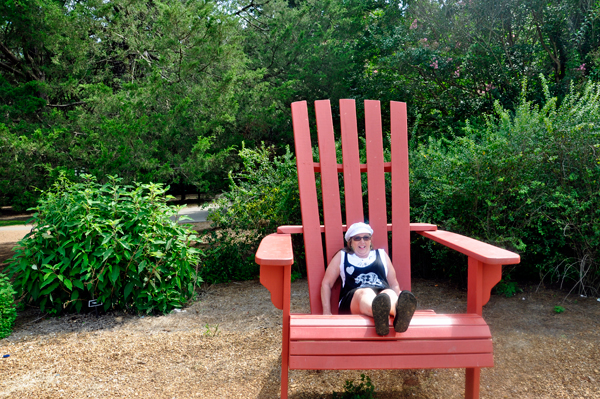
left=0, top=0, right=600, bottom=209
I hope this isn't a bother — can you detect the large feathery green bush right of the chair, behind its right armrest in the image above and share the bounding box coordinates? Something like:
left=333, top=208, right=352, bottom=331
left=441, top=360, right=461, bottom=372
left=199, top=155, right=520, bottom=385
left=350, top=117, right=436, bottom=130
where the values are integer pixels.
left=411, top=77, right=600, bottom=294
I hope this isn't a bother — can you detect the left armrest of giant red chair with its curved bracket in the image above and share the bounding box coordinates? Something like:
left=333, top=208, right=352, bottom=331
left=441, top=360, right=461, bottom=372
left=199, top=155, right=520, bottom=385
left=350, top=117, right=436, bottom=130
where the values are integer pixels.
left=254, top=234, right=294, bottom=310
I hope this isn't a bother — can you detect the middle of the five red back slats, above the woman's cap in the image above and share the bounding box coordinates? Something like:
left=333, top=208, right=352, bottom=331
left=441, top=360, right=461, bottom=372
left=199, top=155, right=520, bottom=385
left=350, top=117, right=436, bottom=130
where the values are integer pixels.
left=340, top=100, right=366, bottom=225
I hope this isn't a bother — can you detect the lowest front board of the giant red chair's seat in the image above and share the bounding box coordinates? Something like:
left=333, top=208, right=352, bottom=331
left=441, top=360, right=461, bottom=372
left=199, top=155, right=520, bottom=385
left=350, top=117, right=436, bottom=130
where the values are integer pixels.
left=290, top=353, right=494, bottom=370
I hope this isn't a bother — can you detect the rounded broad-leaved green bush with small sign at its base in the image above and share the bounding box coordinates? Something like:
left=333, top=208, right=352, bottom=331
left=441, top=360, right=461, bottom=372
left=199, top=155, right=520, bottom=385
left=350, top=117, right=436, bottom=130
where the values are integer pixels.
left=8, top=175, right=199, bottom=314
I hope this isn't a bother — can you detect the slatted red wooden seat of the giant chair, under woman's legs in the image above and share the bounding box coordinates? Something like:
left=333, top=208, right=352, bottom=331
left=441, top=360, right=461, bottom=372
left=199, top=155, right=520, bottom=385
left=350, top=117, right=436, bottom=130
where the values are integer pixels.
left=290, top=311, right=494, bottom=370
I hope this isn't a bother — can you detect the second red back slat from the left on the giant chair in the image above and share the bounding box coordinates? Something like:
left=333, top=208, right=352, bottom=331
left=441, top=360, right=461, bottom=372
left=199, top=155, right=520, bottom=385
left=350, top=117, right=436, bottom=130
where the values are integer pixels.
left=315, top=100, right=344, bottom=266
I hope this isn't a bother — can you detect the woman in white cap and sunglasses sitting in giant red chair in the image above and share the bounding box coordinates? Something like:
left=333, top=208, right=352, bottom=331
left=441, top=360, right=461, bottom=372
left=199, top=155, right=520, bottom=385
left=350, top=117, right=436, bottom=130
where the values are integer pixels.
left=321, top=223, right=417, bottom=335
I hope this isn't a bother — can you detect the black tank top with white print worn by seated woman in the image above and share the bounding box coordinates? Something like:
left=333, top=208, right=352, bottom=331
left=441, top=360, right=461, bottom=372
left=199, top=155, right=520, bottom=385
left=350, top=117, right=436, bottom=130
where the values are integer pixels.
left=340, top=250, right=390, bottom=300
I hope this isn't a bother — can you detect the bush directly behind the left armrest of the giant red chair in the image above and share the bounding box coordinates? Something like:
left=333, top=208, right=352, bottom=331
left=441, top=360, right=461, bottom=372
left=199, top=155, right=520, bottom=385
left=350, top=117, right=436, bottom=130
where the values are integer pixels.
left=201, top=145, right=300, bottom=283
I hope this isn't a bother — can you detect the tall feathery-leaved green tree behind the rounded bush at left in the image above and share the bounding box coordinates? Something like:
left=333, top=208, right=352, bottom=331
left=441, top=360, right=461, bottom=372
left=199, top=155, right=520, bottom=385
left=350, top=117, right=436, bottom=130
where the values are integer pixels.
left=0, top=0, right=251, bottom=207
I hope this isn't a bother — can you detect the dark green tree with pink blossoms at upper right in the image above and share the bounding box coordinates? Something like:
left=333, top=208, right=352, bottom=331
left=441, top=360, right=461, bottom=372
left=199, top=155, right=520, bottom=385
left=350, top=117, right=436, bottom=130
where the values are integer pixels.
left=359, top=0, right=600, bottom=137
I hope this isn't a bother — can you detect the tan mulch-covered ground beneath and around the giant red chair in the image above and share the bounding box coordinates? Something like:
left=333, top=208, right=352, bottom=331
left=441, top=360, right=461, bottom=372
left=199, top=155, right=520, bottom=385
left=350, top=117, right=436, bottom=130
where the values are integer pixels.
left=0, top=238, right=600, bottom=399
